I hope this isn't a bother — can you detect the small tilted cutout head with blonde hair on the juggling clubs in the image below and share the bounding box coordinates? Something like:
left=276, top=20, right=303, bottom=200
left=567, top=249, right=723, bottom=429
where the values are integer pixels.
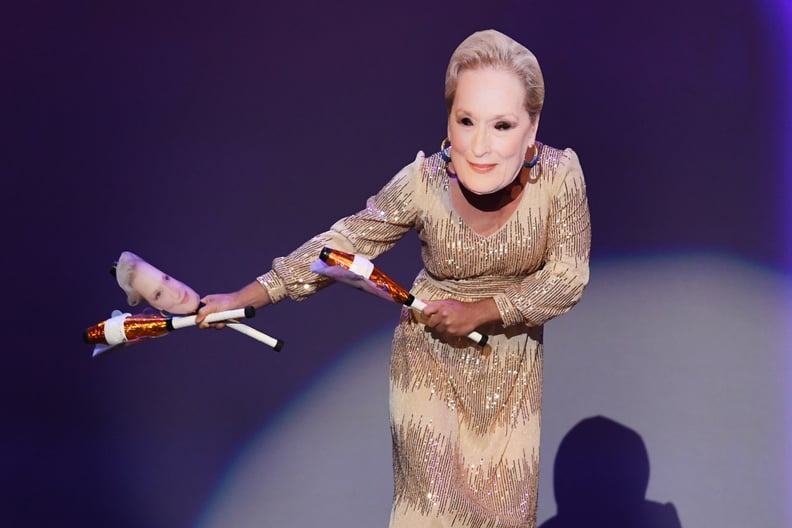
left=115, top=251, right=200, bottom=315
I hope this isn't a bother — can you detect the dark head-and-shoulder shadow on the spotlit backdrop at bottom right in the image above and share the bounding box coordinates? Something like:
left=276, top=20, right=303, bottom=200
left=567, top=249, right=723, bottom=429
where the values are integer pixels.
left=540, top=416, right=682, bottom=528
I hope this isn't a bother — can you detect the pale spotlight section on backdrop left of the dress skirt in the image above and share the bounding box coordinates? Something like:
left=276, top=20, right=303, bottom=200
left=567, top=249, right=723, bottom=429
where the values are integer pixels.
left=198, top=330, right=395, bottom=528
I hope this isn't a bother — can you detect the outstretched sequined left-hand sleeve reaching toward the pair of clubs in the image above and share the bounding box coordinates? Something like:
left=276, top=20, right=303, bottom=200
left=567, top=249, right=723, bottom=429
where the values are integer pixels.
left=257, top=153, right=424, bottom=302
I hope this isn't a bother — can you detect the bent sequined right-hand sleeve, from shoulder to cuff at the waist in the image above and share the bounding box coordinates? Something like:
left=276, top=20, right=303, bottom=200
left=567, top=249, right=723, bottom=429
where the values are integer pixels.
left=495, top=149, right=591, bottom=326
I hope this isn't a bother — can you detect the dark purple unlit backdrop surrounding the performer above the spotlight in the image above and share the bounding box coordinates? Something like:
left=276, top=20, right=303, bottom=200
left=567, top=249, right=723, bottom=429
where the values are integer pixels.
left=0, top=0, right=790, bottom=527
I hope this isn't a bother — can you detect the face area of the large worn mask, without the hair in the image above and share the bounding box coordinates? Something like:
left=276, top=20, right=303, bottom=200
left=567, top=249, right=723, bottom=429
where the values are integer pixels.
left=448, top=68, right=537, bottom=194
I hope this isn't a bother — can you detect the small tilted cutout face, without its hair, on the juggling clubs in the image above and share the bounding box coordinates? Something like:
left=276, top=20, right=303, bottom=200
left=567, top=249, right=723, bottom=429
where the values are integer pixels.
left=131, top=261, right=200, bottom=315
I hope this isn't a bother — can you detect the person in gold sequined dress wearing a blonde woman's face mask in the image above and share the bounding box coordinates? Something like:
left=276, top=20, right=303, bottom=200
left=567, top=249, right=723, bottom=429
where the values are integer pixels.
left=199, top=30, right=591, bottom=528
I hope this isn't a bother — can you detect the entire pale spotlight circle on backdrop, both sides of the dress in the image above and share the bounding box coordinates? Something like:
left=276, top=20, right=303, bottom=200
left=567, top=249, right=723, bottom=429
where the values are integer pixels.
left=200, top=255, right=792, bottom=528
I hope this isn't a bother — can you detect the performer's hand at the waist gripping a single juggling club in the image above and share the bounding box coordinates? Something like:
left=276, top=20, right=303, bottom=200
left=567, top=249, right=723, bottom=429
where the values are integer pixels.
left=423, top=299, right=500, bottom=337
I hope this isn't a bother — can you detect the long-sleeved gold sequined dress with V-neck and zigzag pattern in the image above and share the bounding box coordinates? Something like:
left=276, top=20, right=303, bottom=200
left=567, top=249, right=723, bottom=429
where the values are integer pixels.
left=258, top=145, right=590, bottom=528
